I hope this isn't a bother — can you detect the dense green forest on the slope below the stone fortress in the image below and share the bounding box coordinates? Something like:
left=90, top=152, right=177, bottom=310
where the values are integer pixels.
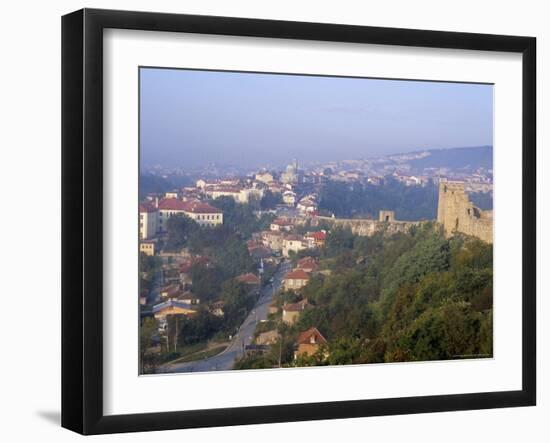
left=238, top=223, right=493, bottom=368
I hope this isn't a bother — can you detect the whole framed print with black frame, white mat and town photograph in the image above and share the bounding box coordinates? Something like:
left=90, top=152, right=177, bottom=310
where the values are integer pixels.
left=62, top=9, right=536, bottom=434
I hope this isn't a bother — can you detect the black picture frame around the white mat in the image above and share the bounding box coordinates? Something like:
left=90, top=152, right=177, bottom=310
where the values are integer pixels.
left=62, top=9, right=536, bottom=434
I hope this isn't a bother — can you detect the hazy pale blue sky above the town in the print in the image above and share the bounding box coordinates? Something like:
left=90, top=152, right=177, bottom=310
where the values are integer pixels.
left=140, top=68, right=493, bottom=168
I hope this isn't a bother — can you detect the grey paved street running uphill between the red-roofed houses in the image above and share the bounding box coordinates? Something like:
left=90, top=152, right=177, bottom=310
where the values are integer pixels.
left=161, top=262, right=290, bottom=373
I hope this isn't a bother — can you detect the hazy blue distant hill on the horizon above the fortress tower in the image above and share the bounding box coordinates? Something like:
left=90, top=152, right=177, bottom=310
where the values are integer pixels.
left=408, top=146, right=493, bottom=173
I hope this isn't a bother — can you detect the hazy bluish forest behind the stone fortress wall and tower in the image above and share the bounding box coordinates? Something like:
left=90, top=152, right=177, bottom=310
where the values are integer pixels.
left=319, top=178, right=493, bottom=221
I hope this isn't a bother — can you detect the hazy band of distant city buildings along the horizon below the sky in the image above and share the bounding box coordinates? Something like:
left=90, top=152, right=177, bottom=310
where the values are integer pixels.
left=141, top=146, right=493, bottom=197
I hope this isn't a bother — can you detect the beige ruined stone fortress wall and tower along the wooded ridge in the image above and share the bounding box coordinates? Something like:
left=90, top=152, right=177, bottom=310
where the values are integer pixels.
left=312, top=181, right=493, bottom=243
